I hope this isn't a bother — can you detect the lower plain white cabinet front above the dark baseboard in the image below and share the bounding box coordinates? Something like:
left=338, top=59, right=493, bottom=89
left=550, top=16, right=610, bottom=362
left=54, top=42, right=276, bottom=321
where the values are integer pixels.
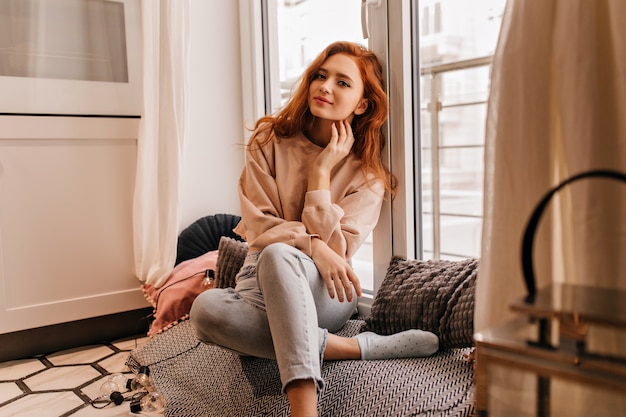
left=0, top=116, right=148, bottom=334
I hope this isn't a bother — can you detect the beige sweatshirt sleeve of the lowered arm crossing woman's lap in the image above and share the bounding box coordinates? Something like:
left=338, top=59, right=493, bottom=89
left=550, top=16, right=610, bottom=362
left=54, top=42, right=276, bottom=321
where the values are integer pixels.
left=235, top=138, right=316, bottom=255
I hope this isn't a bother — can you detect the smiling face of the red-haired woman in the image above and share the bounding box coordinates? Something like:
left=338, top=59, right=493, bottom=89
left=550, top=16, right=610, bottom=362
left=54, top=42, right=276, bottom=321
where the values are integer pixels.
left=309, top=54, right=367, bottom=122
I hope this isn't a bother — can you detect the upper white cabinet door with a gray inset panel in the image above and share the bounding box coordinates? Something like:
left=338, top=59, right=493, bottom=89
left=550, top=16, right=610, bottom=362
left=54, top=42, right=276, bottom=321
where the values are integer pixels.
left=0, top=0, right=142, bottom=116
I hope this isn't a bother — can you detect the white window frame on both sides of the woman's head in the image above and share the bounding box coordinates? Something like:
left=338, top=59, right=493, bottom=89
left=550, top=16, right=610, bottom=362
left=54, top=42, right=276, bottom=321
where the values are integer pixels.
left=239, top=0, right=421, bottom=315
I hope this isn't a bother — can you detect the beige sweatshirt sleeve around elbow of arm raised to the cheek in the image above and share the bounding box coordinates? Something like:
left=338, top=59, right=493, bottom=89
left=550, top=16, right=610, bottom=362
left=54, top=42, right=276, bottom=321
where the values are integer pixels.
left=302, top=176, right=384, bottom=259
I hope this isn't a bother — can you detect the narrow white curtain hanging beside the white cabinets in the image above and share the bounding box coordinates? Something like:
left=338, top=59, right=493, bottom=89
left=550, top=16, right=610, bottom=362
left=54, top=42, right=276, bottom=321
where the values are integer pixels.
left=134, top=0, right=189, bottom=287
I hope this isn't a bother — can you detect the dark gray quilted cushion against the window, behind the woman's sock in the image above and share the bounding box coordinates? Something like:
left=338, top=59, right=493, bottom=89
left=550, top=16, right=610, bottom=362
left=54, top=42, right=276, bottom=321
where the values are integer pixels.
left=363, top=256, right=478, bottom=348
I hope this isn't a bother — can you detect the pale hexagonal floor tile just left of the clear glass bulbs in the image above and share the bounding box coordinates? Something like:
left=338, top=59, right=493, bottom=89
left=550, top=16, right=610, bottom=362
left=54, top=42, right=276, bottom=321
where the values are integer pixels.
left=24, top=365, right=101, bottom=391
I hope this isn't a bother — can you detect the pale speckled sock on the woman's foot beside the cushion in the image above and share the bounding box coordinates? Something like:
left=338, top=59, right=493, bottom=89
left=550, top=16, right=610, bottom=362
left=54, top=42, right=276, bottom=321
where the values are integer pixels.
left=354, top=330, right=439, bottom=360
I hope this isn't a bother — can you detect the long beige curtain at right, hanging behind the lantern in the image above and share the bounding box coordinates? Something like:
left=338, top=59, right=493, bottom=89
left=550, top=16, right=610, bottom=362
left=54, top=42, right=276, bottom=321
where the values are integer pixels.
left=475, top=0, right=626, bottom=416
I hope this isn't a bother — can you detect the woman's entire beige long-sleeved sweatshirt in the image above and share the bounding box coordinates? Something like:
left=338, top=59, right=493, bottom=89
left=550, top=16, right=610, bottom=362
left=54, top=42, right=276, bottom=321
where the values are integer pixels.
left=235, top=127, right=384, bottom=260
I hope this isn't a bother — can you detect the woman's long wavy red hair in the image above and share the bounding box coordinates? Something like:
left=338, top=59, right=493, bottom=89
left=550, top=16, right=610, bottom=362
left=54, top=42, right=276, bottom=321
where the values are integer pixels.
left=249, top=41, right=396, bottom=196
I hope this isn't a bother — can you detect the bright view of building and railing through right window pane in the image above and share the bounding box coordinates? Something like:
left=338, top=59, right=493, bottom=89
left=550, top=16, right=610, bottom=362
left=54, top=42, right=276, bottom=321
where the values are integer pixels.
left=419, top=0, right=505, bottom=259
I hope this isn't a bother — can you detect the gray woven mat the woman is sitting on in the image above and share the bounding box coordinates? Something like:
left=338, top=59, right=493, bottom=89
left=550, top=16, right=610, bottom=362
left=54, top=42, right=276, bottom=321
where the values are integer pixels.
left=127, top=320, right=474, bottom=417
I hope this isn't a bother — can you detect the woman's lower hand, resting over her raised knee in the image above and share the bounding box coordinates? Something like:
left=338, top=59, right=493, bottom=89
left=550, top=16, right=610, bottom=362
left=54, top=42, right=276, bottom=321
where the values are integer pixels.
left=311, top=239, right=362, bottom=302
